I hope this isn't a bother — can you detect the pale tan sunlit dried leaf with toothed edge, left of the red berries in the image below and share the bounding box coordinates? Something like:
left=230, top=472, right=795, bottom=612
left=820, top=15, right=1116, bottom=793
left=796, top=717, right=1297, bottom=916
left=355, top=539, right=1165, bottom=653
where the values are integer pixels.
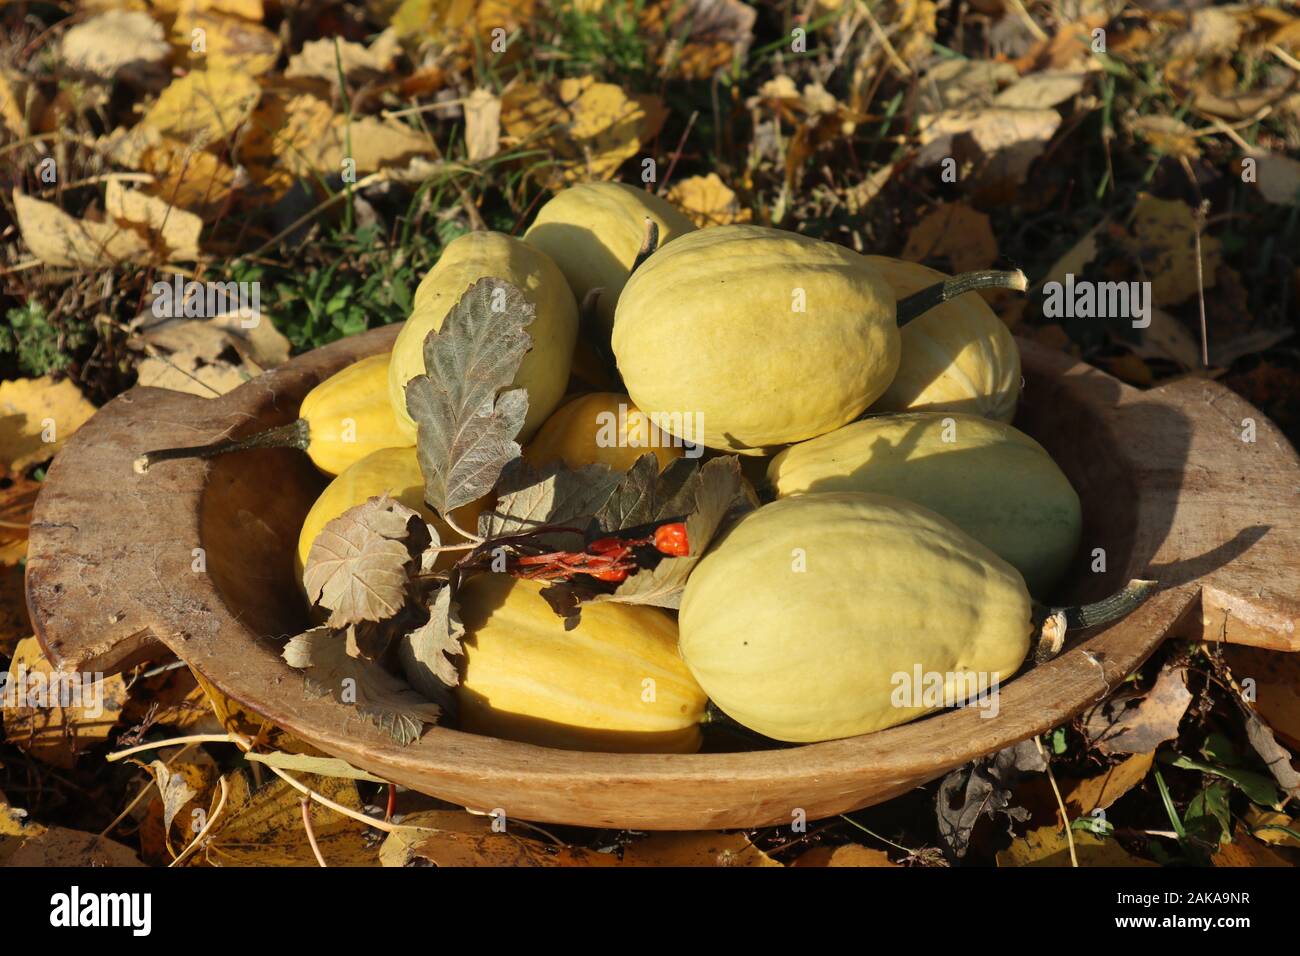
left=303, top=494, right=421, bottom=627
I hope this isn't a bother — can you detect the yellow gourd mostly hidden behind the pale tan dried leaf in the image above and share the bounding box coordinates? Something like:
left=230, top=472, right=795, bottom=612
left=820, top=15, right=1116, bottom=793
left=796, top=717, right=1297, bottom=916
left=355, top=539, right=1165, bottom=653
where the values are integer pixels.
left=294, top=447, right=486, bottom=587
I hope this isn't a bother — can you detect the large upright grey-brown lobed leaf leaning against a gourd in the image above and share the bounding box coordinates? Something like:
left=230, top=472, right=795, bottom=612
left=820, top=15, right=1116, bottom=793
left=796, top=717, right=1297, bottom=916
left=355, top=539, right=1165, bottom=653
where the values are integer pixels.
left=406, top=278, right=537, bottom=515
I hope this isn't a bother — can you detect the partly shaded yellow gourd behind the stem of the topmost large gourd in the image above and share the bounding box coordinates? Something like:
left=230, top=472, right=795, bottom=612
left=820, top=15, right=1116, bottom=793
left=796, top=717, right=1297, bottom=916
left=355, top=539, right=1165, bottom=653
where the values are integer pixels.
left=867, top=256, right=1021, bottom=421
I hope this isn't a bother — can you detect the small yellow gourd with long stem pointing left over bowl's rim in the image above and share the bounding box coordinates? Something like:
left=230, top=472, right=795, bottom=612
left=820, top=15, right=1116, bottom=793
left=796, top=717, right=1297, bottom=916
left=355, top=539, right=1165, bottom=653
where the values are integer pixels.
left=135, top=352, right=416, bottom=475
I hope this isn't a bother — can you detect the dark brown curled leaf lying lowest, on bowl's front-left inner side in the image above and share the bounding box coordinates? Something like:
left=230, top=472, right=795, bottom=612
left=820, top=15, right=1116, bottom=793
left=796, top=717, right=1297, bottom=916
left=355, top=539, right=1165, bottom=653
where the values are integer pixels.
left=282, top=627, right=442, bottom=744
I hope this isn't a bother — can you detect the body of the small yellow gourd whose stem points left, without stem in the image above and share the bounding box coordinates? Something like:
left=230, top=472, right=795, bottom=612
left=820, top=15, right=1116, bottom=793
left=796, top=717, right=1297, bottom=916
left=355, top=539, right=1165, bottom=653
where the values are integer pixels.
left=298, top=352, right=415, bottom=475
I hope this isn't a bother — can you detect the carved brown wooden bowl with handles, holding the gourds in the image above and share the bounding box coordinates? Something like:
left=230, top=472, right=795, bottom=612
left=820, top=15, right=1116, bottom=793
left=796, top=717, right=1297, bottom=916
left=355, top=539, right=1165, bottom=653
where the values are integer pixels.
left=27, top=326, right=1300, bottom=830
